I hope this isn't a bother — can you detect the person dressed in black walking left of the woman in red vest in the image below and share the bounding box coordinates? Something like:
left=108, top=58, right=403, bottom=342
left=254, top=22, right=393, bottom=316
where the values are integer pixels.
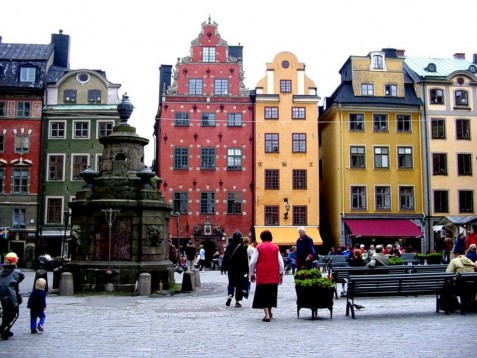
left=222, top=231, right=248, bottom=307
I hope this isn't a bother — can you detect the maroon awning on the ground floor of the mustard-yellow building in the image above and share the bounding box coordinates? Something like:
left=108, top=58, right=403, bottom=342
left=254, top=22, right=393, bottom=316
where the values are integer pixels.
left=343, top=219, right=423, bottom=239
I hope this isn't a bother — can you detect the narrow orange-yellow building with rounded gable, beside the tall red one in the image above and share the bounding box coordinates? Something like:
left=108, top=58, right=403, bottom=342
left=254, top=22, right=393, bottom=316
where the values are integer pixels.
left=254, top=52, right=322, bottom=246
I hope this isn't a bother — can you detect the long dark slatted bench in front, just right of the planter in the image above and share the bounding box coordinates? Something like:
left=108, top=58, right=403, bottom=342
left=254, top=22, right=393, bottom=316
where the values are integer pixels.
left=346, top=272, right=455, bottom=318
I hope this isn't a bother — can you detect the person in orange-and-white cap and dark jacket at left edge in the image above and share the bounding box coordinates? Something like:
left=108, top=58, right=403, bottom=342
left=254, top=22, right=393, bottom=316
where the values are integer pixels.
left=0, top=252, right=25, bottom=340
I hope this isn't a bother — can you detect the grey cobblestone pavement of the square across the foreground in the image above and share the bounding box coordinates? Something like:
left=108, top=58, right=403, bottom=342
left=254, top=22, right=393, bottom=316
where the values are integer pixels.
left=0, top=271, right=477, bottom=358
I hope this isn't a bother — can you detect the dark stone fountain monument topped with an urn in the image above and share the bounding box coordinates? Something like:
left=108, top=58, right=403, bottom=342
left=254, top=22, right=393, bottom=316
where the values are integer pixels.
left=66, top=95, right=174, bottom=292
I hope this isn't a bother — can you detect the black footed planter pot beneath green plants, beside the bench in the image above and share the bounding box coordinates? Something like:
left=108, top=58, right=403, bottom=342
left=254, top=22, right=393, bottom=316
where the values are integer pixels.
left=295, top=285, right=335, bottom=319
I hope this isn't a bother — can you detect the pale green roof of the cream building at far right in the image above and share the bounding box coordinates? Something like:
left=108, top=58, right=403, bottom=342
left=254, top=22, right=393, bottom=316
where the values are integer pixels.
left=404, top=57, right=475, bottom=77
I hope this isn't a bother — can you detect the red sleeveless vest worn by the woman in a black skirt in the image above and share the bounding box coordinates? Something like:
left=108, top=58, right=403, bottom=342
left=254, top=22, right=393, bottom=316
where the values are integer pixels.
left=255, top=241, right=280, bottom=285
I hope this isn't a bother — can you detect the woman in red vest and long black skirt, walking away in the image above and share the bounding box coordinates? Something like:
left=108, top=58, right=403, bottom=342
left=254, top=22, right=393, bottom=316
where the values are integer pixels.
left=250, top=230, right=284, bottom=322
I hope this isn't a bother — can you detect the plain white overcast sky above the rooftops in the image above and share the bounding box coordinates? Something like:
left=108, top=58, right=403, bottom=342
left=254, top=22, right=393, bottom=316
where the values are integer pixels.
left=0, top=0, right=477, bottom=165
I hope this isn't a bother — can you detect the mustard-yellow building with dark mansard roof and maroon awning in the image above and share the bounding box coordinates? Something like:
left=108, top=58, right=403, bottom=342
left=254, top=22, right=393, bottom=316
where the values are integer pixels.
left=319, top=49, right=426, bottom=250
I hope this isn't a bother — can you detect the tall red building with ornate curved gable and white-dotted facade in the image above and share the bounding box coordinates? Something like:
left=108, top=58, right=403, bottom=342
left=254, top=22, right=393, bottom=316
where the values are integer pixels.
left=156, top=18, right=253, bottom=261
